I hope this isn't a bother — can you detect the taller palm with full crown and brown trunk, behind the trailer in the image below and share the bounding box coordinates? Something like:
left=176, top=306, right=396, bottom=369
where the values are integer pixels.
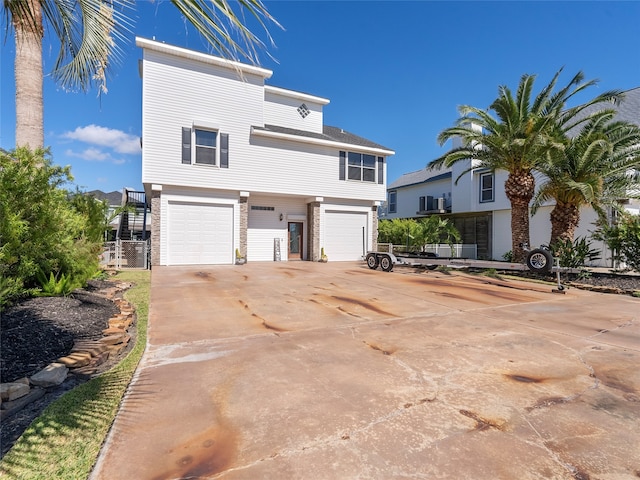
left=428, top=69, right=620, bottom=261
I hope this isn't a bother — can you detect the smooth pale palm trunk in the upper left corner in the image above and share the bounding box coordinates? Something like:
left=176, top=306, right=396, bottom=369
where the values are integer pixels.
left=13, top=0, right=44, bottom=149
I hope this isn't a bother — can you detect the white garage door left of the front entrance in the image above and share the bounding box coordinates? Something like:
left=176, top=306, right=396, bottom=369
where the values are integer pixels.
left=167, top=203, right=233, bottom=265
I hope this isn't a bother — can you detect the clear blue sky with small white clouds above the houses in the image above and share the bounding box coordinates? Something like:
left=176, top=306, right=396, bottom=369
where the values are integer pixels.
left=0, top=0, right=640, bottom=192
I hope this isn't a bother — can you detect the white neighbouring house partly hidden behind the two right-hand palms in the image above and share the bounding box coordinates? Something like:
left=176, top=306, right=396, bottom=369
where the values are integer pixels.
left=381, top=87, right=640, bottom=267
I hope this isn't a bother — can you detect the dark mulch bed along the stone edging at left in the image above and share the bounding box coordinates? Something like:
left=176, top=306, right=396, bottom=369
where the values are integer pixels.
left=0, top=280, right=135, bottom=458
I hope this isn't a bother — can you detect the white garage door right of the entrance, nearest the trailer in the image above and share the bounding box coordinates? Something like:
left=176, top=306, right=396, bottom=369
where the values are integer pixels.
left=323, top=211, right=368, bottom=261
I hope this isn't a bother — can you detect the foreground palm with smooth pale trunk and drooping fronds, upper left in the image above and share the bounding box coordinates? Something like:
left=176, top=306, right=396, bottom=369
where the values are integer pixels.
left=3, top=0, right=279, bottom=148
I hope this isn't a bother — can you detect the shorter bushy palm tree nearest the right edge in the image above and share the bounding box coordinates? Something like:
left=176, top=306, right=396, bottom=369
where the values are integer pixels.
left=531, top=110, right=640, bottom=245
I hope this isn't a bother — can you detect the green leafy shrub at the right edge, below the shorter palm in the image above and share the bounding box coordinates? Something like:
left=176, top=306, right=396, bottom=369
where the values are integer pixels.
left=593, top=212, right=640, bottom=272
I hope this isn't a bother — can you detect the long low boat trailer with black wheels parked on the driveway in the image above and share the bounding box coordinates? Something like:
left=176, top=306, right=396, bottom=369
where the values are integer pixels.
left=365, top=244, right=580, bottom=293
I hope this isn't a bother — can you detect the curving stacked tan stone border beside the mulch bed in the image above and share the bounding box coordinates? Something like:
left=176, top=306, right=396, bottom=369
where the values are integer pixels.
left=0, top=282, right=136, bottom=420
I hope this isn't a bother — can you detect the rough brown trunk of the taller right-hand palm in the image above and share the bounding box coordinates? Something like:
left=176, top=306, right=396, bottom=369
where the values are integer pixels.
left=504, top=171, right=535, bottom=262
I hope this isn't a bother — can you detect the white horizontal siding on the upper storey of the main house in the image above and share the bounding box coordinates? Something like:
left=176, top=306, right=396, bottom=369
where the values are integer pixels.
left=142, top=50, right=386, bottom=202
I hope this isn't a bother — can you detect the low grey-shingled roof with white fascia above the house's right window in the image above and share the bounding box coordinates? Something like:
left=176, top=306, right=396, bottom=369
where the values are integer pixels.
left=251, top=125, right=395, bottom=155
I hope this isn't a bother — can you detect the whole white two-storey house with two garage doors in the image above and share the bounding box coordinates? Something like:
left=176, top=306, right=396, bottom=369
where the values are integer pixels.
left=136, top=38, right=394, bottom=265
